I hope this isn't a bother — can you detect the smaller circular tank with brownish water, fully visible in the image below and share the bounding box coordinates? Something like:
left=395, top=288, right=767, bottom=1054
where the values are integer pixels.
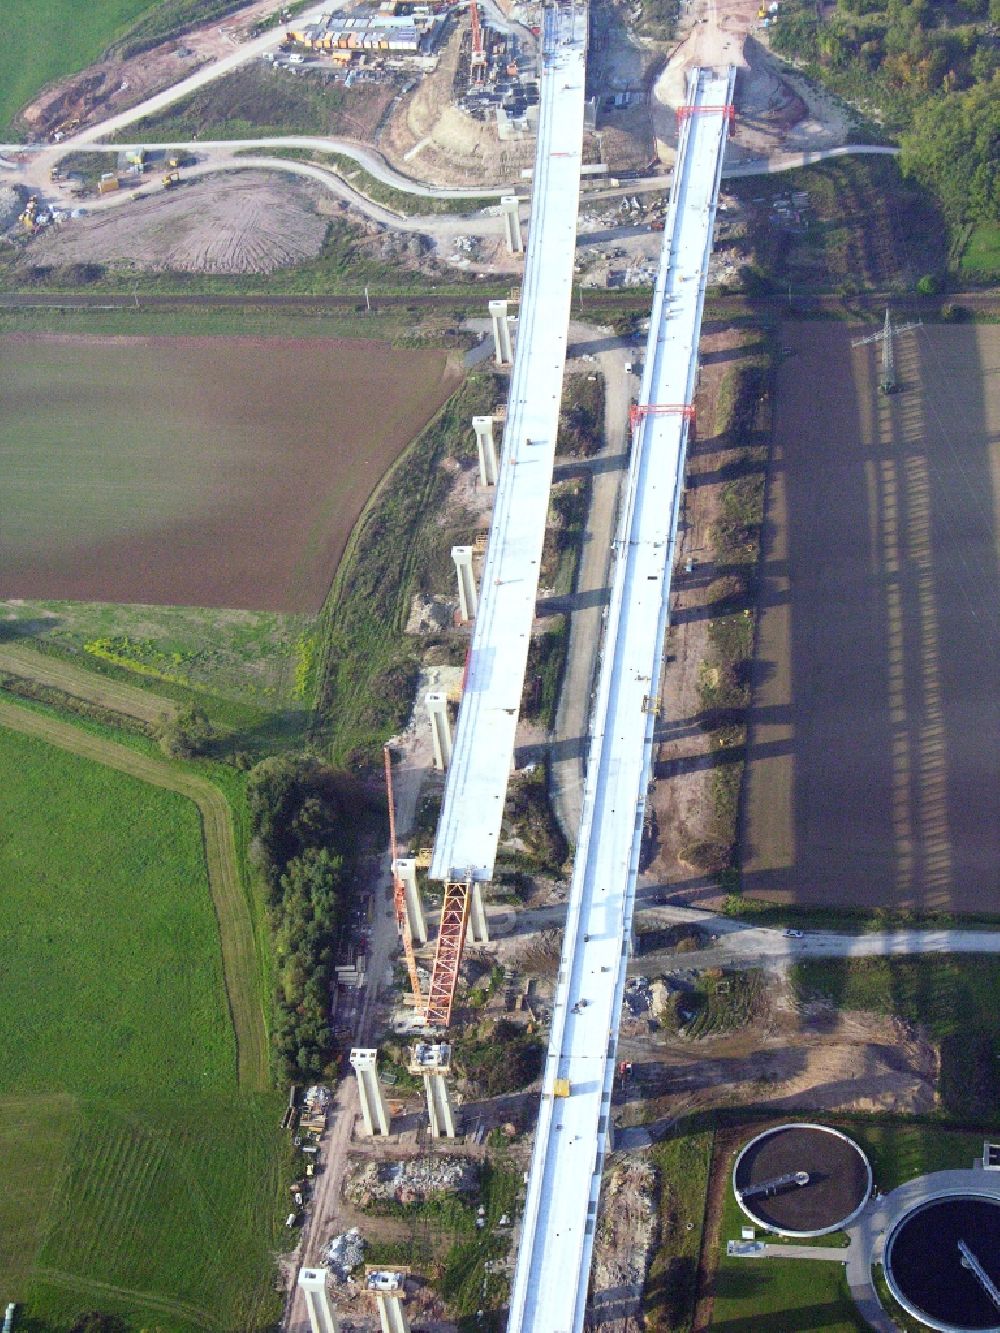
left=732, top=1124, right=872, bottom=1236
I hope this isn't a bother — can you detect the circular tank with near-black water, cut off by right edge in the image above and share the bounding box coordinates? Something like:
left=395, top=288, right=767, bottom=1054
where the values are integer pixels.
left=884, top=1193, right=1000, bottom=1333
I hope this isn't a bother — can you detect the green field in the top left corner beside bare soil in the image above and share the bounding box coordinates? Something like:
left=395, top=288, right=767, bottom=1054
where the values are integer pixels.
left=0, top=0, right=156, bottom=128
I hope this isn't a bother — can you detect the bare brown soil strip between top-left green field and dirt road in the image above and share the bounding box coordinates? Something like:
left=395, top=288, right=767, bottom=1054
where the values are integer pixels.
left=19, top=0, right=284, bottom=140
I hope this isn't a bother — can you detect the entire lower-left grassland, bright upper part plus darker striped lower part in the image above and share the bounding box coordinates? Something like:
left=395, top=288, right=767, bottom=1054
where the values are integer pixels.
left=0, top=728, right=285, bottom=1333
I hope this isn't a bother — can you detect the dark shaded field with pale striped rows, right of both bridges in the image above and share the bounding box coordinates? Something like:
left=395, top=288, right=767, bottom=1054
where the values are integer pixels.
left=741, top=324, right=1000, bottom=913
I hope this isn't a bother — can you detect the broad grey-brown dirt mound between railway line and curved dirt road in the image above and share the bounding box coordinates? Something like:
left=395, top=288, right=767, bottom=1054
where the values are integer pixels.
left=28, top=172, right=327, bottom=273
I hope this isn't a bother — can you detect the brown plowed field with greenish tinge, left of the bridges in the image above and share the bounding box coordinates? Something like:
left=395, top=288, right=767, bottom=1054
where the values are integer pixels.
left=0, top=335, right=457, bottom=612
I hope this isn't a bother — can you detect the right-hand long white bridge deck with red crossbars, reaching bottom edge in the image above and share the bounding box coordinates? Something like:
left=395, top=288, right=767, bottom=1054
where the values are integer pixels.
left=508, top=69, right=735, bottom=1333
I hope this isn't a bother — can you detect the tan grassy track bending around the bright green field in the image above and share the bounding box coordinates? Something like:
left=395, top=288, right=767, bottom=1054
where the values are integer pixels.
left=0, top=701, right=269, bottom=1092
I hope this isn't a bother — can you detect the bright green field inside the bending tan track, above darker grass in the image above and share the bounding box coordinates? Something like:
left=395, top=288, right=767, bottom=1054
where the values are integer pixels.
left=0, top=729, right=236, bottom=1096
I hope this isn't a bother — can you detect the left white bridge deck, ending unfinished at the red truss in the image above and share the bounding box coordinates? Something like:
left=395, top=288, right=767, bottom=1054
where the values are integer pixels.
left=431, top=3, right=587, bottom=880
